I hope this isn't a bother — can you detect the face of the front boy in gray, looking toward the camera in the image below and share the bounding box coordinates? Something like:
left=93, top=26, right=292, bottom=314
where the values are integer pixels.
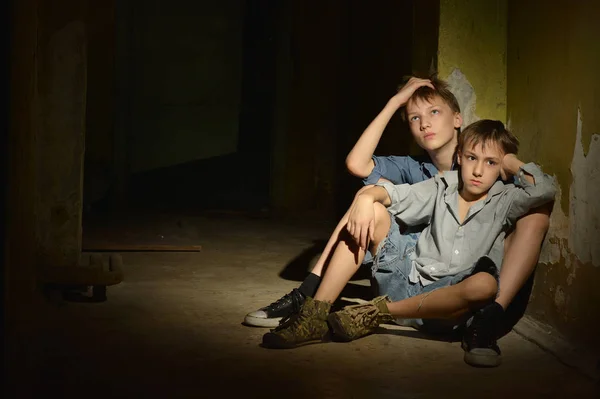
left=457, top=142, right=504, bottom=200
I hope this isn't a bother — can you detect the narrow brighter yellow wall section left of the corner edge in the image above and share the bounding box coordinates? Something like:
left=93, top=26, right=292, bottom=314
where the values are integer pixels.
left=438, top=0, right=507, bottom=126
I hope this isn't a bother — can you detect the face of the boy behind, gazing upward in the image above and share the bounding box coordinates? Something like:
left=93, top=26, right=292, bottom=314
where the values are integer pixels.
left=406, top=96, right=462, bottom=152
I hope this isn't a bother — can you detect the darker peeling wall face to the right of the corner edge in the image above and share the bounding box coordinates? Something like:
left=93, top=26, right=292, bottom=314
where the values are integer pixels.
left=507, top=0, right=600, bottom=348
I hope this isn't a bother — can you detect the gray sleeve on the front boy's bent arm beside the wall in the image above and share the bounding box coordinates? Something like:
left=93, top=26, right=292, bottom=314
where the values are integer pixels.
left=507, top=163, right=556, bottom=223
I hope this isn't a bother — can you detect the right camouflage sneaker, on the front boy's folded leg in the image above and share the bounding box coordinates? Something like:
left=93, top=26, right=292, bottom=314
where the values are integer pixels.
left=328, top=296, right=394, bottom=341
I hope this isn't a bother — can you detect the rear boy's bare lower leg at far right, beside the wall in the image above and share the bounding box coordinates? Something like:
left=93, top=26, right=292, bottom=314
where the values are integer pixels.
left=496, top=205, right=551, bottom=309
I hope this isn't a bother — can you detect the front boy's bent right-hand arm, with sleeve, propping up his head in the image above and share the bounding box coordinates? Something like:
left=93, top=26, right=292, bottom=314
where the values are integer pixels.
left=502, top=154, right=556, bottom=223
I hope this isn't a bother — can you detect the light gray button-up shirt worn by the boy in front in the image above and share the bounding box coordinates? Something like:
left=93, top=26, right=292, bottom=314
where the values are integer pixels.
left=377, top=163, right=556, bottom=285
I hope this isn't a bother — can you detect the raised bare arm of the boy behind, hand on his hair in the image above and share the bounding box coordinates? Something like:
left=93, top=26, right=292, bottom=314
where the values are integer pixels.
left=346, top=77, right=434, bottom=178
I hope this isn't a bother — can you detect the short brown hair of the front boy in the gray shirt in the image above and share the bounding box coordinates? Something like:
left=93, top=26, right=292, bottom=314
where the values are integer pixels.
left=456, top=119, right=519, bottom=154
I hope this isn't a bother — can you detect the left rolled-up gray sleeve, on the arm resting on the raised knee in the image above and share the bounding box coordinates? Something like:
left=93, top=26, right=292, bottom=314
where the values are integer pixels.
left=377, top=178, right=438, bottom=225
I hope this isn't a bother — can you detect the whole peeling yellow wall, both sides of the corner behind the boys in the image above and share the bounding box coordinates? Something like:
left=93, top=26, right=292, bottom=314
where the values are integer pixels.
left=438, top=0, right=600, bottom=353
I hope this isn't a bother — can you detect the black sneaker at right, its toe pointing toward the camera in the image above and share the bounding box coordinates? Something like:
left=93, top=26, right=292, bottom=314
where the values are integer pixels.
left=462, top=302, right=502, bottom=367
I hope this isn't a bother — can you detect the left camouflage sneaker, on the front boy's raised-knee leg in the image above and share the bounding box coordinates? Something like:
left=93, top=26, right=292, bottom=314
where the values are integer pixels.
left=263, top=297, right=331, bottom=349
